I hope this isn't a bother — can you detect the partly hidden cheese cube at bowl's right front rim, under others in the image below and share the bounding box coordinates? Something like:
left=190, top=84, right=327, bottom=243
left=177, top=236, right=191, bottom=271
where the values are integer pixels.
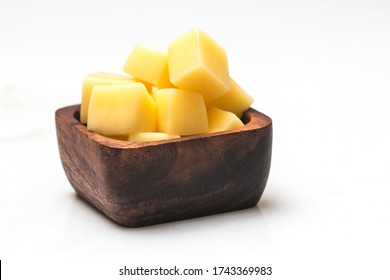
left=207, top=107, right=244, bottom=133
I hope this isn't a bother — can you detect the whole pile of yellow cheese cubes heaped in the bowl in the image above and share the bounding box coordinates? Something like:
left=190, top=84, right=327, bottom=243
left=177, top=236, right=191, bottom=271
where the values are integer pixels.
left=80, top=29, right=253, bottom=141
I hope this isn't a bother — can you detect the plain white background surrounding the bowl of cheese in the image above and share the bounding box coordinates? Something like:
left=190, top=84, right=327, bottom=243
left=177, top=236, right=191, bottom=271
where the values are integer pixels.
left=0, top=0, right=390, bottom=279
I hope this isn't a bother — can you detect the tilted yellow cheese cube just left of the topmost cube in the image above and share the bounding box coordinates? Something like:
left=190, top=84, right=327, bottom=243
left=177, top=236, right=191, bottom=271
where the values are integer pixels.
left=123, top=43, right=173, bottom=88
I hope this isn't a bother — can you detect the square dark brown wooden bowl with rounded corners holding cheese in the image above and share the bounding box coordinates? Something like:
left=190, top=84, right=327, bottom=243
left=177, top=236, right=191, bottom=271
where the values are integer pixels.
left=55, top=105, right=272, bottom=227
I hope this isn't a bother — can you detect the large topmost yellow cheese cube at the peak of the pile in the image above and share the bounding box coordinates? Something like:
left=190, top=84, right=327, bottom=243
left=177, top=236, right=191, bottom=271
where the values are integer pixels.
left=168, top=29, right=230, bottom=102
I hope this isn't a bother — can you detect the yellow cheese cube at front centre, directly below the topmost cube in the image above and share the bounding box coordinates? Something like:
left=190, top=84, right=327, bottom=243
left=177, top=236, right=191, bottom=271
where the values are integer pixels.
left=153, top=88, right=208, bottom=135
